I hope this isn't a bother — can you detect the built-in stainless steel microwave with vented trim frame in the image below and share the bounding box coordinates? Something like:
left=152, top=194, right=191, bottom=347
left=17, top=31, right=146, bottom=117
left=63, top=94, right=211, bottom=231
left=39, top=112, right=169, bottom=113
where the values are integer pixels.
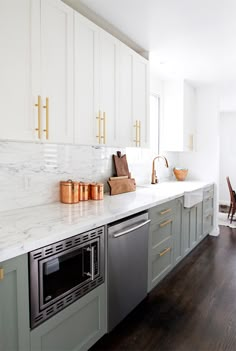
left=29, top=227, right=104, bottom=328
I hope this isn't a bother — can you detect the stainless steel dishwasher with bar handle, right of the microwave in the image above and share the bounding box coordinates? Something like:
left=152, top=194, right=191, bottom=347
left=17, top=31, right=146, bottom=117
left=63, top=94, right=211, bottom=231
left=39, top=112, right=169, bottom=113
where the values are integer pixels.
left=108, top=212, right=150, bottom=331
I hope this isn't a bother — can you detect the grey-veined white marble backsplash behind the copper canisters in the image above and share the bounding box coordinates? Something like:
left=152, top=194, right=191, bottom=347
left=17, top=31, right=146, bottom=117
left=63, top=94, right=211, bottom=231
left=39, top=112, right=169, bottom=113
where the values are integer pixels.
left=0, top=141, right=175, bottom=211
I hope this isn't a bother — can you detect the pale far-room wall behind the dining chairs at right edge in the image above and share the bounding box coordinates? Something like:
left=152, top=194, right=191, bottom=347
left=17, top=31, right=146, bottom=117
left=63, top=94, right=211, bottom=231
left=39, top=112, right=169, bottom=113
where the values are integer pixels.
left=219, top=111, right=236, bottom=205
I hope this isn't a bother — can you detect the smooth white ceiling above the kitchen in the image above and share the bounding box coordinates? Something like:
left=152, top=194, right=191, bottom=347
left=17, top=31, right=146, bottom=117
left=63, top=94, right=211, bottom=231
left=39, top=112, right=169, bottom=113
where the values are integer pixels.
left=74, top=0, right=236, bottom=82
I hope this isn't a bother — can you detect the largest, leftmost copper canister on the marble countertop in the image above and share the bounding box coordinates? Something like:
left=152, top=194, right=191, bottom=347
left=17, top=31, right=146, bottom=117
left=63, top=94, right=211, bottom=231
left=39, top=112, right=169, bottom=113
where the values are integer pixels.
left=60, top=179, right=79, bottom=204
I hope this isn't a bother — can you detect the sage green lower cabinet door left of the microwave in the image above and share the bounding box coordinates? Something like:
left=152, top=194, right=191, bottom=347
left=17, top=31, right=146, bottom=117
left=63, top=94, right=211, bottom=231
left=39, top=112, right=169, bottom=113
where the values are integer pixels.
left=0, top=254, right=30, bottom=351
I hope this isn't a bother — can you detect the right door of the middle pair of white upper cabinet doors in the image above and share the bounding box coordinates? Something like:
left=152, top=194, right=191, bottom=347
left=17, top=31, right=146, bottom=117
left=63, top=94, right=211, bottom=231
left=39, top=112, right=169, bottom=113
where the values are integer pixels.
left=99, top=30, right=119, bottom=146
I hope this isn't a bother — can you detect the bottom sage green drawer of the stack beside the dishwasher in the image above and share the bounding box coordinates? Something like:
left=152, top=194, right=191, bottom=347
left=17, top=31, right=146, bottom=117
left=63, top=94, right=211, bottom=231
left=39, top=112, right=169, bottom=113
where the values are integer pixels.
left=151, top=238, right=173, bottom=288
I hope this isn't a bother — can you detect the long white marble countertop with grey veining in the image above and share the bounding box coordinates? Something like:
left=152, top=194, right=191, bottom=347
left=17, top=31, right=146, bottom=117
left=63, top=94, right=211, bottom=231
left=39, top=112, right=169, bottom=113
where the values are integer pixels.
left=0, top=181, right=211, bottom=262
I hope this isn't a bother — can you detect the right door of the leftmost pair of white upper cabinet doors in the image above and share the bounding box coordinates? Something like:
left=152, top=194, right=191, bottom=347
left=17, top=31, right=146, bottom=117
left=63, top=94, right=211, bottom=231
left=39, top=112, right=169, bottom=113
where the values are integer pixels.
left=40, top=0, right=74, bottom=142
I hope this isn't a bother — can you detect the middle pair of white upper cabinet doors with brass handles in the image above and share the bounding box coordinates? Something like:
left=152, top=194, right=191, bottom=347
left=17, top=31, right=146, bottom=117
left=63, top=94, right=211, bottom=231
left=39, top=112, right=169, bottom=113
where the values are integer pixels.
left=74, top=13, right=119, bottom=145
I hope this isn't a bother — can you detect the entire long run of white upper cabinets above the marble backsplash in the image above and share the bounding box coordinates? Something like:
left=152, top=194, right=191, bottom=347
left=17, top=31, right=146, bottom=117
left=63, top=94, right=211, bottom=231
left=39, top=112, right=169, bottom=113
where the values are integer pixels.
left=0, top=0, right=149, bottom=147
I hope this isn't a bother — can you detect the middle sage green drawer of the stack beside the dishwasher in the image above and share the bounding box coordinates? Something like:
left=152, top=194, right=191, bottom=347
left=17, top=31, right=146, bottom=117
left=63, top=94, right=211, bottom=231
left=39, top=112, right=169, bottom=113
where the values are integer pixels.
left=150, top=216, right=174, bottom=248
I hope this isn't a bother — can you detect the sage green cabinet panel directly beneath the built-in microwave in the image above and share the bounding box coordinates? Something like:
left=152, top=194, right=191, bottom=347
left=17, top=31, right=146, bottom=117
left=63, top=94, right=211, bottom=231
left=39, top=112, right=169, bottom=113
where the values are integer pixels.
left=31, top=284, right=107, bottom=351
